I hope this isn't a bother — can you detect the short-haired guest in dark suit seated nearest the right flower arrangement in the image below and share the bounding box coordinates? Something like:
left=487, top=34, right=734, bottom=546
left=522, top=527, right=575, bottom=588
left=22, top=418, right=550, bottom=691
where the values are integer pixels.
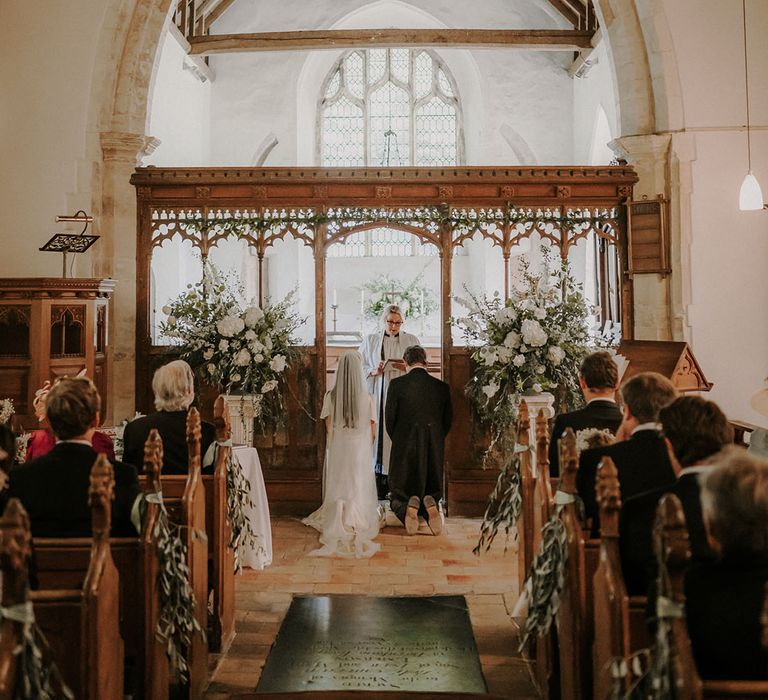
left=549, top=350, right=621, bottom=476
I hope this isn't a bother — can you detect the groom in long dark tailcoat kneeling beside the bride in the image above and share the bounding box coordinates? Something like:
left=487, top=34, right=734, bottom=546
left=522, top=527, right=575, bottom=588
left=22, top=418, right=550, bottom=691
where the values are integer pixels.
left=385, top=345, right=451, bottom=535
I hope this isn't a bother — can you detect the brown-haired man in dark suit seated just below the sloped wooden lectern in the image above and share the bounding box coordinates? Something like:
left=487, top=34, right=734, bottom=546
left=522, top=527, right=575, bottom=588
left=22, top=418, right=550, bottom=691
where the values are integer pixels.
left=576, top=372, right=677, bottom=536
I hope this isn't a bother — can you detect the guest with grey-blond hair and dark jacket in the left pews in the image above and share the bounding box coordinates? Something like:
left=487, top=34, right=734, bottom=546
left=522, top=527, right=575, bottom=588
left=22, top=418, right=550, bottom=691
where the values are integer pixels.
left=123, top=360, right=216, bottom=474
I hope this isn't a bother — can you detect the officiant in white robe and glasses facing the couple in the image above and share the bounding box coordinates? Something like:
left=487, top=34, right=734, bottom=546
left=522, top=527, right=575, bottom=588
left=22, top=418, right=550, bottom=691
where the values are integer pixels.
left=360, top=304, right=419, bottom=499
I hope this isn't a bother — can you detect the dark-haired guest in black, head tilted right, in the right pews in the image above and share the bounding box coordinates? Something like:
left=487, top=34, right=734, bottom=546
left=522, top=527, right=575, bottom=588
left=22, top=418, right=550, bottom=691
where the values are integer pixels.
left=619, top=396, right=733, bottom=595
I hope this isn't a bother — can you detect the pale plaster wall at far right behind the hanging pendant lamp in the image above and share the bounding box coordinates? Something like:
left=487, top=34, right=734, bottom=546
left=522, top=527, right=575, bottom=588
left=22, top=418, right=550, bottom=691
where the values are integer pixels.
left=664, top=0, right=768, bottom=425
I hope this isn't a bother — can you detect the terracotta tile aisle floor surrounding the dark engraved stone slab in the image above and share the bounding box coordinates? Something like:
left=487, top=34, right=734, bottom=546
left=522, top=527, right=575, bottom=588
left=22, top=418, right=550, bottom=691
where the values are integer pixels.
left=205, top=518, right=537, bottom=700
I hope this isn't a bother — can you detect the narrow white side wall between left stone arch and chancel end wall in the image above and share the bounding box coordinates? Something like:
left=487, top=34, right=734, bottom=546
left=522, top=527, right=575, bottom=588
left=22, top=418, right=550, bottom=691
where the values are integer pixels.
left=143, top=32, right=211, bottom=167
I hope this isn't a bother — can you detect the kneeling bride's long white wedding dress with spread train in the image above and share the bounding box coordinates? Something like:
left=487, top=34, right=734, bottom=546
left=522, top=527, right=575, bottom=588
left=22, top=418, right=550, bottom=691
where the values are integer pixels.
left=302, top=392, right=380, bottom=558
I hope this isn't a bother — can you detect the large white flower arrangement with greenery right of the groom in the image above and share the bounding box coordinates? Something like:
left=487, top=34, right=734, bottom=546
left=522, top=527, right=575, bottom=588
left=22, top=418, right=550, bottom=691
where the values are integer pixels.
left=451, top=257, right=590, bottom=440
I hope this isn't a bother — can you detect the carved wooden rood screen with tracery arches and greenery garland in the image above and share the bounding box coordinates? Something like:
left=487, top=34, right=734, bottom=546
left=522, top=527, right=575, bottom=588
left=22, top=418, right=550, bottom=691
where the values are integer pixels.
left=131, top=166, right=637, bottom=514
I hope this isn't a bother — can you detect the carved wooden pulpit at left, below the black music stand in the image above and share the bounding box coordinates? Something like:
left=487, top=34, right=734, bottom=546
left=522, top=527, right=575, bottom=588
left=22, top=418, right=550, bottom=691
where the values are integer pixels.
left=0, top=277, right=115, bottom=428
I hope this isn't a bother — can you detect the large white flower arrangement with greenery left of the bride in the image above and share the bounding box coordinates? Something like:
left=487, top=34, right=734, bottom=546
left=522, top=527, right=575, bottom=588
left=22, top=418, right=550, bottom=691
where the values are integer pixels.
left=160, top=261, right=306, bottom=427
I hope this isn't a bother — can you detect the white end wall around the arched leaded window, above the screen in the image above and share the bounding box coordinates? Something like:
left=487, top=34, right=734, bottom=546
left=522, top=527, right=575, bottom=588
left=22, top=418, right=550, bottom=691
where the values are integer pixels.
left=211, top=0, right=573, bottom=166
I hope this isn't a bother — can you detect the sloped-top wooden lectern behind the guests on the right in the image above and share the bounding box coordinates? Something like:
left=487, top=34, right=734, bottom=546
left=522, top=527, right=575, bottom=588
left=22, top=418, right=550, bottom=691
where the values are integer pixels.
left=616, top=340, right=713, bottom=392
